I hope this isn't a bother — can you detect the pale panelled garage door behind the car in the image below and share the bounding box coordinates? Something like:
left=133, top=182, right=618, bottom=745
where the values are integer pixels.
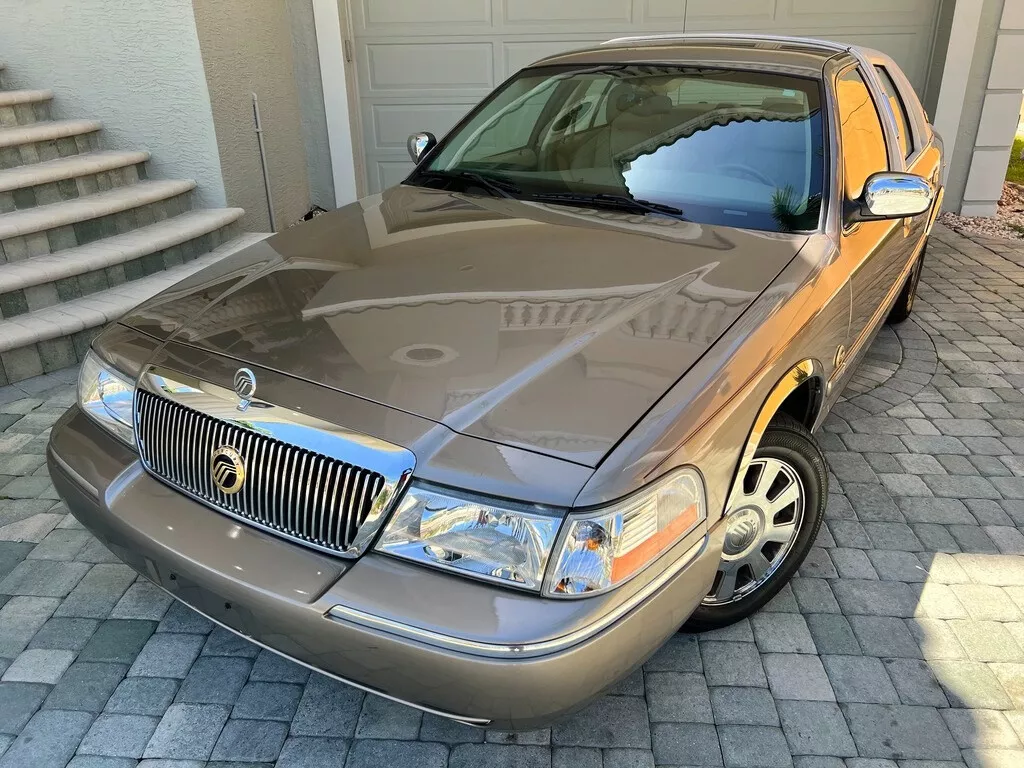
left=347, top=0, right=940, bottom=193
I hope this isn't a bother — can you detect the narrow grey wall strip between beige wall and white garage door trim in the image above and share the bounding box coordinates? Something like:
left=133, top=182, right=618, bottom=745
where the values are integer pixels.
left=287, top=0, right=334, bottom=210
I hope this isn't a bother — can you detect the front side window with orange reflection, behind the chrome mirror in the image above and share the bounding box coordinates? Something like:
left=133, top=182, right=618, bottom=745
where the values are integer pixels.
left=836, top=69, right=889, bottom=200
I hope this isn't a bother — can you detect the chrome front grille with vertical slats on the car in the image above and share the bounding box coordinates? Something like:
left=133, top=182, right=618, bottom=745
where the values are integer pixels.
left=134, top=368, right=416, bottom=558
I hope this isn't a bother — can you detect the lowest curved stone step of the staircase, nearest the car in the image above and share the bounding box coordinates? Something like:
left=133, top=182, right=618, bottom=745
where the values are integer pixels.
left=0, top=233, right=269, bottom=386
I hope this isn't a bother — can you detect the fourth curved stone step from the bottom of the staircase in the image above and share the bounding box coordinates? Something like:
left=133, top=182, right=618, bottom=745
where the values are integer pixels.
left=0, top=151, right=150, bottom=214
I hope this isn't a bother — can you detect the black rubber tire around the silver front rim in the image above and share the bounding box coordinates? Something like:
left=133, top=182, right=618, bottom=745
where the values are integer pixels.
left=682, top=414, right=828, bottom=632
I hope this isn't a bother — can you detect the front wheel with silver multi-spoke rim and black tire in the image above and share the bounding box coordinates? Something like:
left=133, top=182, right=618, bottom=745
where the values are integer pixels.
left=683, top=415, right=828, bottom=632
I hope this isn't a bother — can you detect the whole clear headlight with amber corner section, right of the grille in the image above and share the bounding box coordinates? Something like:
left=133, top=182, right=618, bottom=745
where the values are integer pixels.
left=376, top=468, right=707, bottom=597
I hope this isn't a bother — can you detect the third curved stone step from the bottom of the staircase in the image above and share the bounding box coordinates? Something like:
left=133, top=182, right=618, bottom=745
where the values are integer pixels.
left=0, top=180, right=196, bottom=264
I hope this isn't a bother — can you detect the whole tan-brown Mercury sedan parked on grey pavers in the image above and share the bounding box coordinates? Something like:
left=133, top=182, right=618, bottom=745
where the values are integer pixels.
left=48, top=36, right=942, bottom=729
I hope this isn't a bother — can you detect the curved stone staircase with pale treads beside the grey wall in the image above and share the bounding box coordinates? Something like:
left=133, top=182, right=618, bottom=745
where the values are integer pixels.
left=0, top=62, right=266, bottom=386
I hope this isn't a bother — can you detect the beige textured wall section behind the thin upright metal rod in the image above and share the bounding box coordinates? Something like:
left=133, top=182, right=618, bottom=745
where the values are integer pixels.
left=193, top=0, right=309, bottom=231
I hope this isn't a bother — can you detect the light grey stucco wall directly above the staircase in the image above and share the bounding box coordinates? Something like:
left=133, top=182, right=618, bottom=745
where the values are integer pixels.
left=0, top=0, right=224, bottom=207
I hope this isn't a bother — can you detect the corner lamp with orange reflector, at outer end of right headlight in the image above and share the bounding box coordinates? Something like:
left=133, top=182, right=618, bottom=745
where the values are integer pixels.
left=545, top=469, right=707, bottom=596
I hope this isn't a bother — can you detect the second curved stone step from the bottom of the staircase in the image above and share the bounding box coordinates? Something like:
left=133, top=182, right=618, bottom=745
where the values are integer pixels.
left=0, top=208, right=245, bottom=319
